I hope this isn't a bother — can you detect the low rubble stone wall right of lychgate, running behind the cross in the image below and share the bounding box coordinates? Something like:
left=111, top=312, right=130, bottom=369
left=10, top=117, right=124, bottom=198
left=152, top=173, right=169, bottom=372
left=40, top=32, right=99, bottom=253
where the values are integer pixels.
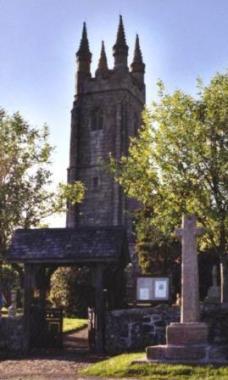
left=105, top=304, right=228, bottom=353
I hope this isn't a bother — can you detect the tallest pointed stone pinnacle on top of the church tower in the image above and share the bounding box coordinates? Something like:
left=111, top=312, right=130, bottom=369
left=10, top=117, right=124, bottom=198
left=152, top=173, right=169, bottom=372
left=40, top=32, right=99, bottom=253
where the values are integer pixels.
left=113, top=16, right=128, bottom=68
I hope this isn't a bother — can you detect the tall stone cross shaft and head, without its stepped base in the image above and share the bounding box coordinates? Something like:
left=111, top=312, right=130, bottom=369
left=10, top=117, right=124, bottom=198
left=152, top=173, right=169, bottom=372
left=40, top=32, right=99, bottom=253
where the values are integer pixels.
left=176, top=215, right=204, bottom=323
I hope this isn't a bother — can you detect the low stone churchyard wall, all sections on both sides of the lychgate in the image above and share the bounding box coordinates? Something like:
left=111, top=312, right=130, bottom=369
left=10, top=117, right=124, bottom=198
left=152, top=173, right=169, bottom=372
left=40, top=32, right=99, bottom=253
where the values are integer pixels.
left=0, top=304, right=228, bottom=354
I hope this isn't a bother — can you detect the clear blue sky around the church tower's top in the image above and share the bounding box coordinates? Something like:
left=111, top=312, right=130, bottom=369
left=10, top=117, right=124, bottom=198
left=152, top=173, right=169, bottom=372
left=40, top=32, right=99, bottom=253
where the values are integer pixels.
left=0, top=0, right=228, bottom=224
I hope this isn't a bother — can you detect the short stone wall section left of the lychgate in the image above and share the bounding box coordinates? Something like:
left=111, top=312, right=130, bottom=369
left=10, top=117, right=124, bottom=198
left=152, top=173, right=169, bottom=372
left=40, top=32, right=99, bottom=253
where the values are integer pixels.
left=0, top=317, right=23, bottom=356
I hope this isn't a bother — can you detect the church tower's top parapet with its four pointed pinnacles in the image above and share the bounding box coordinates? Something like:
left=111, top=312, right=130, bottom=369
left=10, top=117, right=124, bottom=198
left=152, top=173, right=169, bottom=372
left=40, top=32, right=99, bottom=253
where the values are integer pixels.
left=76, top=16, right=145, bottom=104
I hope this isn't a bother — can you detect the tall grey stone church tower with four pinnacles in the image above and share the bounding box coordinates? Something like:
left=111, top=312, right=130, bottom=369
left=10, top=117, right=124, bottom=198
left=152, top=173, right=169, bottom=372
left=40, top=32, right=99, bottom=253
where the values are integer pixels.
left=67, top=16, right=145, bottom=232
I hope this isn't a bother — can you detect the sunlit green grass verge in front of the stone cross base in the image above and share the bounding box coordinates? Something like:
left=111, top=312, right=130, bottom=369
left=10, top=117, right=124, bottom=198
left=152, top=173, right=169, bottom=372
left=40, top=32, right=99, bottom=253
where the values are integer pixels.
left=81, top=353, right=228, bottom=380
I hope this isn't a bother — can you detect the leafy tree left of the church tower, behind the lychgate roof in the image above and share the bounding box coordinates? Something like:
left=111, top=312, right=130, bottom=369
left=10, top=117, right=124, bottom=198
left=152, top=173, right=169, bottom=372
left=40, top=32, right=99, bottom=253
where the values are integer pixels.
left=0, top=110, right=84, bottom=258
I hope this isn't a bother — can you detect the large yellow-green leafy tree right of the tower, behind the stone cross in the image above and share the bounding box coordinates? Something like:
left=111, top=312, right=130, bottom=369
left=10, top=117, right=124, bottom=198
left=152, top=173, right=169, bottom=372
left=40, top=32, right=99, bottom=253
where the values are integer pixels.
left=111, top=73, right=228, bottom=284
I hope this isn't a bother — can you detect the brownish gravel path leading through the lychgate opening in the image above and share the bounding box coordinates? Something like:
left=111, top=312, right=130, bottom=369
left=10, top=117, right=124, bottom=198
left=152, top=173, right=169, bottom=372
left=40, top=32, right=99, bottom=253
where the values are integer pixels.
left=0, top=329, right=107, bottom=380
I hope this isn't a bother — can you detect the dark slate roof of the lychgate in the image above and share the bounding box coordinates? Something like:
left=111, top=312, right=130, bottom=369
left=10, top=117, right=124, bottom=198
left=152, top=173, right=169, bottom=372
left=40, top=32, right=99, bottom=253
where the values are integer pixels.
left=8, top=227, right=129, bottom=263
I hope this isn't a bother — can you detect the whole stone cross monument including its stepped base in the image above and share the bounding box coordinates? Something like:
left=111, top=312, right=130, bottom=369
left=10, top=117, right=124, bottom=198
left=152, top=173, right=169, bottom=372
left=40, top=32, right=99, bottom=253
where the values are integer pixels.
left=146, top=215, right=208, bottom=362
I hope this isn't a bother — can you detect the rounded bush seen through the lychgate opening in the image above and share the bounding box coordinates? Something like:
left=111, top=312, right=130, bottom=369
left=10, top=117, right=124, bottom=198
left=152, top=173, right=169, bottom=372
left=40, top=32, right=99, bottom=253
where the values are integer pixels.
left=50, top=267, right=91, bottom=317
